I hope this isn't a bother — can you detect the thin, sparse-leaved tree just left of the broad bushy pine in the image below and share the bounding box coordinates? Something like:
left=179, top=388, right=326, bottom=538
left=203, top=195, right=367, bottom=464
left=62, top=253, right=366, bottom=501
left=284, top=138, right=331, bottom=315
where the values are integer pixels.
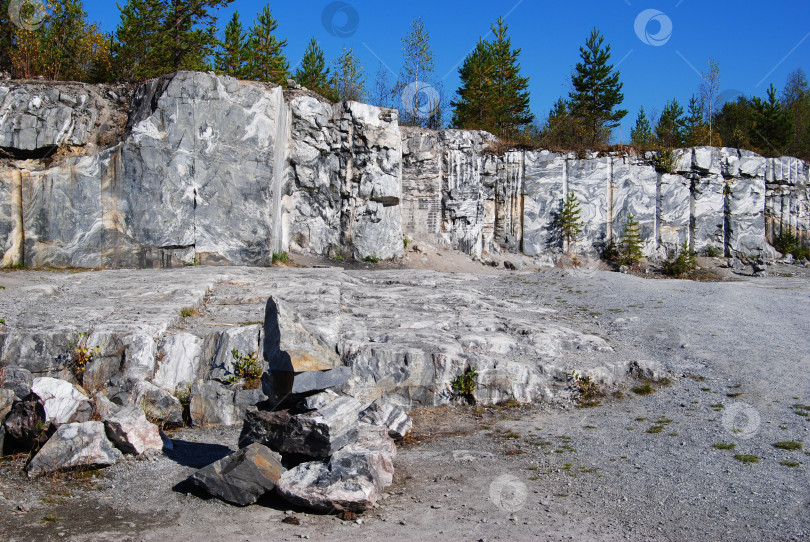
left=394, top=17, right=440, bottom=126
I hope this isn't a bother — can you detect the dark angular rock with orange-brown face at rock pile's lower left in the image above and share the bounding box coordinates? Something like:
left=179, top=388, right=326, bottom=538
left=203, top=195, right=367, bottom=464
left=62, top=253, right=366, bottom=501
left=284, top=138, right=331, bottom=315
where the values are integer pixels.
left=189, top=444, right=285, bottom=506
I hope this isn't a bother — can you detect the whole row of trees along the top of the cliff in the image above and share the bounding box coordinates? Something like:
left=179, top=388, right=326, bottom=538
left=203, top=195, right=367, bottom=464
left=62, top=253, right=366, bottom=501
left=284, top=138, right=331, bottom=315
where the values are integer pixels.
left=0, top=0, right=810, bottom=159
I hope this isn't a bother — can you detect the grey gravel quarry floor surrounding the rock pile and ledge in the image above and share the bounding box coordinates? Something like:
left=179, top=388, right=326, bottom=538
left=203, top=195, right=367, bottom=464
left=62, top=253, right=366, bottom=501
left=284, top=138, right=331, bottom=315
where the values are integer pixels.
left=0, top=255, right=810, bottom=542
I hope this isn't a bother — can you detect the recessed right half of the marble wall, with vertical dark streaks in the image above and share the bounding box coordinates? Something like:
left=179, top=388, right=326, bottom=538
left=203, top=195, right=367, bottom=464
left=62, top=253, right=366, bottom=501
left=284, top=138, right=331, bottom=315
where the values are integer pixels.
left=402, top=128, right=810, bottom=257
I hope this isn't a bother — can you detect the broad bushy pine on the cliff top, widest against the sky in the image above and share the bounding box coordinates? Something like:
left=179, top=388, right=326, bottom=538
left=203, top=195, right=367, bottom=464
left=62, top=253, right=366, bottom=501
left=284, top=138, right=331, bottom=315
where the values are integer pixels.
left=451, top=17, right=534, bottom=137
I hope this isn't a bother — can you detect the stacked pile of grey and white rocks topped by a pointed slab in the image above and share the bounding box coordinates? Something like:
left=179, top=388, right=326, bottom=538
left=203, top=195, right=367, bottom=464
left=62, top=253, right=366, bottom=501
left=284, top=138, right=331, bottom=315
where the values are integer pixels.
left=190, top=298, right=412, bottom=513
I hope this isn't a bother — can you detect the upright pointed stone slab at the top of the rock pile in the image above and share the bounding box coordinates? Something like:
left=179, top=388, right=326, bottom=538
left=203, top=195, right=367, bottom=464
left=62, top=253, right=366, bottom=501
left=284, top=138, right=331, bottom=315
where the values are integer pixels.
left=264, top=297, right=341, bottom=373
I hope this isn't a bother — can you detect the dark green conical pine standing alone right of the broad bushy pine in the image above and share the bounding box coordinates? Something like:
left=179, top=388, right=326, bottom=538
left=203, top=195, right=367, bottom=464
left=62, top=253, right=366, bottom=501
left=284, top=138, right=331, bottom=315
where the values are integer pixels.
left=569, top=28, right=627, bottom=145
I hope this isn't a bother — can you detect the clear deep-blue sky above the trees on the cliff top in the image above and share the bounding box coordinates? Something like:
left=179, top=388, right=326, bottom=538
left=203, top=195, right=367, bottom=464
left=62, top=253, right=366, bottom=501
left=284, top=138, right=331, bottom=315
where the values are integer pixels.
left=85, top=0, right=810, bottom=140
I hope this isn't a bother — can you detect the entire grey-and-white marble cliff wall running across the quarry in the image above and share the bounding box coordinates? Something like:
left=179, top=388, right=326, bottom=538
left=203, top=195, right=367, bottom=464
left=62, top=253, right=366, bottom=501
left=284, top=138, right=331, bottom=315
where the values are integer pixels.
left=0, top=72, right=810, bottom=268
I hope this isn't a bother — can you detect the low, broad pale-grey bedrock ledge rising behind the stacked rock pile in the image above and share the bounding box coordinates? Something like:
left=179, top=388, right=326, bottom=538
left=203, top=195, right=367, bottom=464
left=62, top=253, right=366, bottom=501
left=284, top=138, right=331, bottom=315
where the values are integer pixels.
left=0, top=267, right=638, bottom=416
